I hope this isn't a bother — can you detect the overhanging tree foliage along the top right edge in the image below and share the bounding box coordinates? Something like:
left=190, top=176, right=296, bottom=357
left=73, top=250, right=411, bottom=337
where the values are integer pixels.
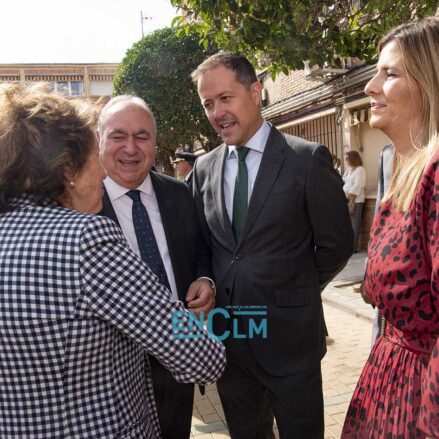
left=171, top=0, right=439, bottom=74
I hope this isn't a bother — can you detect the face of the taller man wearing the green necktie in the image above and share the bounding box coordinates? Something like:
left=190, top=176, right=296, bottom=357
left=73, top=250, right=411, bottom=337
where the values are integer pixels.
left=198, top=66, right=262, bottom=146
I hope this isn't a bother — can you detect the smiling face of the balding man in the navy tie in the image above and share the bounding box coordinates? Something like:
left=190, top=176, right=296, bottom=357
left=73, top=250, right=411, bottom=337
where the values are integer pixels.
left=98, top=102, right=155, bottom=189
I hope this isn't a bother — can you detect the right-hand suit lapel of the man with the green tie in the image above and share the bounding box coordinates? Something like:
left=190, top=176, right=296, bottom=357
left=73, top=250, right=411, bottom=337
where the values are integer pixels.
left=241, top=128, right=287, bottom=242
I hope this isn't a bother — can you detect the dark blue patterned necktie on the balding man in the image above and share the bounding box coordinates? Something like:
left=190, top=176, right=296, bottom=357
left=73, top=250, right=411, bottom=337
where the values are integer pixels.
left=127, top=189, right=170, bottom=289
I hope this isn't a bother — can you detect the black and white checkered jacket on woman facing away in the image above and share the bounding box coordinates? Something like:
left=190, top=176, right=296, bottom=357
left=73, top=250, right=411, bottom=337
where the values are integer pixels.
left=0, top=196, right=225, bottom=439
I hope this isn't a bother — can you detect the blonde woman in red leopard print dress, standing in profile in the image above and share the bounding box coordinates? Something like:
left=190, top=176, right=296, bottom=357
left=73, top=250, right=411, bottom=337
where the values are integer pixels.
left=342, top=17, right=439, bottom=439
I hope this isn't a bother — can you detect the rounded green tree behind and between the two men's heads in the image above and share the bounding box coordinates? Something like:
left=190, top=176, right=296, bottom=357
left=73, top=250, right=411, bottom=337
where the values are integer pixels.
left=114, top=28, right=219, bottom=172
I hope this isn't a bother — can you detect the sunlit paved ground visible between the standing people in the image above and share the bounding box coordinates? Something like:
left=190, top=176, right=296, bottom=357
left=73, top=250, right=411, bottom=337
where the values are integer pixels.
left=191, top=252, right=375, bottom=439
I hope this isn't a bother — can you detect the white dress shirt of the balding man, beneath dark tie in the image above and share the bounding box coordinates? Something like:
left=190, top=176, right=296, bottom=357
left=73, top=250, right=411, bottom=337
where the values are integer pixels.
left=104, top=174, right=179, bottom=300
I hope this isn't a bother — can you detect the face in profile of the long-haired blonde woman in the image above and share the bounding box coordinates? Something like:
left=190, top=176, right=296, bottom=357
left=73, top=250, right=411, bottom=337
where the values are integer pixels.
left=364, top=40, right=422, bottom=151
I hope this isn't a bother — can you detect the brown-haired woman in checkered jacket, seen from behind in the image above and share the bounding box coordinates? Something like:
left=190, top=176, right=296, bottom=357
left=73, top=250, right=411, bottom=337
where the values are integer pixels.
left=0, top=84, right=225, bottom=439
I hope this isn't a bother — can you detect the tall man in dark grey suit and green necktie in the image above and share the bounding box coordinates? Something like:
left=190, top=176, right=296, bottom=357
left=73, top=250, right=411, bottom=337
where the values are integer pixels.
left=192, top=53, right=353, bottom=439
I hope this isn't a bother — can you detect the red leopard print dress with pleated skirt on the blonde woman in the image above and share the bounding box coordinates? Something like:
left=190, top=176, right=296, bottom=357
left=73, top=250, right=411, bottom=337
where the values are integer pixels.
left=341, top=153, right=439, bottom=439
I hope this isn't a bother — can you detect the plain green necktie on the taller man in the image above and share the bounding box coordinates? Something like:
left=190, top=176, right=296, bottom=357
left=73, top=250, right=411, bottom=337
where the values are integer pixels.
left=232, top=150, right=250, bottom=242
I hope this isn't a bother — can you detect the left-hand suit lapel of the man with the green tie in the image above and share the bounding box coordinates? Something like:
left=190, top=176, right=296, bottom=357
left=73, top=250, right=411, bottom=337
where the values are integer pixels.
left=211, top=144, right=236, bottom=248
